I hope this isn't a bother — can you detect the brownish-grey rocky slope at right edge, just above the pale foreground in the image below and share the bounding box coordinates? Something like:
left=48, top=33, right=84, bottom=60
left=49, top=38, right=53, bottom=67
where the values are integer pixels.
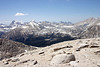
left=79, top=20, right=100, bottom=38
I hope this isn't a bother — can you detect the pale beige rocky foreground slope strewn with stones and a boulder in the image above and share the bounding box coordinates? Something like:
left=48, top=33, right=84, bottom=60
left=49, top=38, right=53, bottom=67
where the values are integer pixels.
left=0, top=38, right=100, bottom=67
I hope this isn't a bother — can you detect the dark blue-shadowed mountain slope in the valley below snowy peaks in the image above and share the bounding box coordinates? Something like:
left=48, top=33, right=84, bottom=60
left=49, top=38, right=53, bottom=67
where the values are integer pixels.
left=2, top=29, right=75, bottom=47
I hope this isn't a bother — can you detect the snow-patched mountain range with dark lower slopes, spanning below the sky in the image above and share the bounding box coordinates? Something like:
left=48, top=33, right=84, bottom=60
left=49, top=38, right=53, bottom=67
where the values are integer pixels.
left=0, top=18, right=100, bottom=47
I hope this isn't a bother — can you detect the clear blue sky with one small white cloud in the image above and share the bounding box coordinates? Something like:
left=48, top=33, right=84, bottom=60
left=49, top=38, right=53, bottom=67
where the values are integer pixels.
left=0, top=0, right=100, bottom=24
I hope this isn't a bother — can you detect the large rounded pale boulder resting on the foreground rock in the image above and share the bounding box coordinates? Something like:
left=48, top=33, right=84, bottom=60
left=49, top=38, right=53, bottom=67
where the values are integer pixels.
left=50, top=54, right=75, bottom=65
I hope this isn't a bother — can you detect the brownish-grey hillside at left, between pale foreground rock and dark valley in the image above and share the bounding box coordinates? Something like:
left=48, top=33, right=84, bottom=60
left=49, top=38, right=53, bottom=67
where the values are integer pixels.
left=0, top=39, right=35, bottom=59
